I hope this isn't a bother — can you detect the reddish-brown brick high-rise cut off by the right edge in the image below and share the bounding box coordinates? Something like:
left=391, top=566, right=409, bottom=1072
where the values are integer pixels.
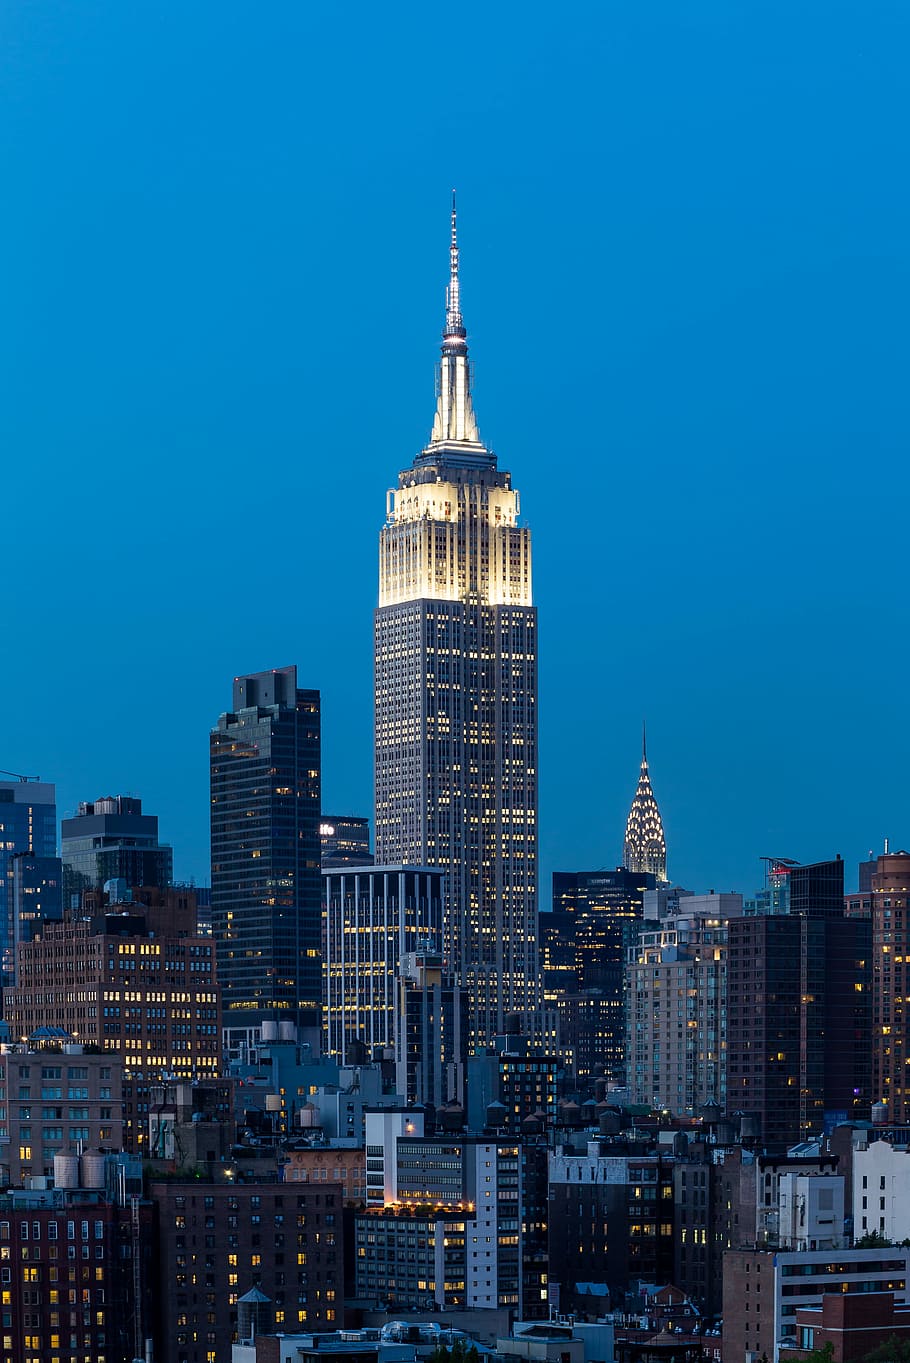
left=872, top=852, right=910, bottom=1124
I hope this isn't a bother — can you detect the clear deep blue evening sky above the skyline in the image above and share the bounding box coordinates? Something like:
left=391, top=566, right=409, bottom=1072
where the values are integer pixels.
left=0, top=0, right=910, bottom=904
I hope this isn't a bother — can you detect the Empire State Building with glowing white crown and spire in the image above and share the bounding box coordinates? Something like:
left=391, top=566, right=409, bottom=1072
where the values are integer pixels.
left=375, top=204, right=538, bottom=1048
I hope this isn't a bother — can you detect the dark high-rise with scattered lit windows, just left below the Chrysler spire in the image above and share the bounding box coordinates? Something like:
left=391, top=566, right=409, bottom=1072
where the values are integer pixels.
left=539, top=867, right=657, bottom=1082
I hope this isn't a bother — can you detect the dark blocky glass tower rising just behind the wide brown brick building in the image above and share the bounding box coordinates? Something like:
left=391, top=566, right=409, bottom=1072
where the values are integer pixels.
left=60, top=795, right=174, bottom=910
